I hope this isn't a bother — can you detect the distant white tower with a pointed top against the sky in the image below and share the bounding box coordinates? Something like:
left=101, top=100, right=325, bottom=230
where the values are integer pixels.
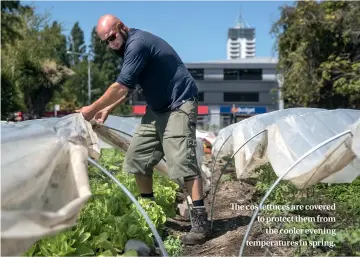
left=226, top=14, right=256, bottom=60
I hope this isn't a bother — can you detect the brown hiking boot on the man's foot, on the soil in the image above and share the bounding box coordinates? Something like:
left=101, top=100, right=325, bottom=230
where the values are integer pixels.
left=182, top=206, right=209, bottom=245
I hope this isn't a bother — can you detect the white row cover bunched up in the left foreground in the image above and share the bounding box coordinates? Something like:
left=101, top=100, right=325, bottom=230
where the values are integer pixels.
left=1, top=114, right=100, bottom=256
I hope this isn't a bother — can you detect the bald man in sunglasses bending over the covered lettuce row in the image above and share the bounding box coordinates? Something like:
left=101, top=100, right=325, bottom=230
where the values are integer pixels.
left=78, top=15, right=209, bottom=245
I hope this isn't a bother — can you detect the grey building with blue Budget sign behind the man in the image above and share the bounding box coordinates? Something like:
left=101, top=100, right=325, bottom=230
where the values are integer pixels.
left=132, top=57, right=281, bottom=131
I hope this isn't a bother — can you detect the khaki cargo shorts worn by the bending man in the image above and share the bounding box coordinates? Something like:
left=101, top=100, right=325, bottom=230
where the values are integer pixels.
left=124, top=100, right=200, bottom=180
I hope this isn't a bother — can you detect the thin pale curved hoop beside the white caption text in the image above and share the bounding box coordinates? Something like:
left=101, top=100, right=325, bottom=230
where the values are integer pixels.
left=239, top=130, right=352, bottom=257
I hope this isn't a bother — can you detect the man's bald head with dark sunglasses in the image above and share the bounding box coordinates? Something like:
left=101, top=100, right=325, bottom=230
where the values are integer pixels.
left=96, top=14, right=129, bottom=51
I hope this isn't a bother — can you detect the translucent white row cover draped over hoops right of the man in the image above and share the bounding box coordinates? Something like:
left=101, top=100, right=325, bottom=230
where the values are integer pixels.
left=213, top=108, right=360, bottom=188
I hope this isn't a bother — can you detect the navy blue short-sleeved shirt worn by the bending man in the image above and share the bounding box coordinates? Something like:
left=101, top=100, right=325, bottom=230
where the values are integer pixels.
left=116, top=29, right=198, bottom=112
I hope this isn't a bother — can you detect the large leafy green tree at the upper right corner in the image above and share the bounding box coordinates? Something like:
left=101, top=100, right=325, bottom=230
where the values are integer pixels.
left=271, top=1, right=360, bottom=109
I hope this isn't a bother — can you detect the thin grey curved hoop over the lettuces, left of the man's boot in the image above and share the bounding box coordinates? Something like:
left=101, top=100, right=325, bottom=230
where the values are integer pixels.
left=88, top=157, right=169, bottom=257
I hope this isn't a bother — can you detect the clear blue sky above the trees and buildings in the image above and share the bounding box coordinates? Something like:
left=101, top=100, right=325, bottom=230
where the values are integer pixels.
left=23, top=1, right=292, bottom=62
